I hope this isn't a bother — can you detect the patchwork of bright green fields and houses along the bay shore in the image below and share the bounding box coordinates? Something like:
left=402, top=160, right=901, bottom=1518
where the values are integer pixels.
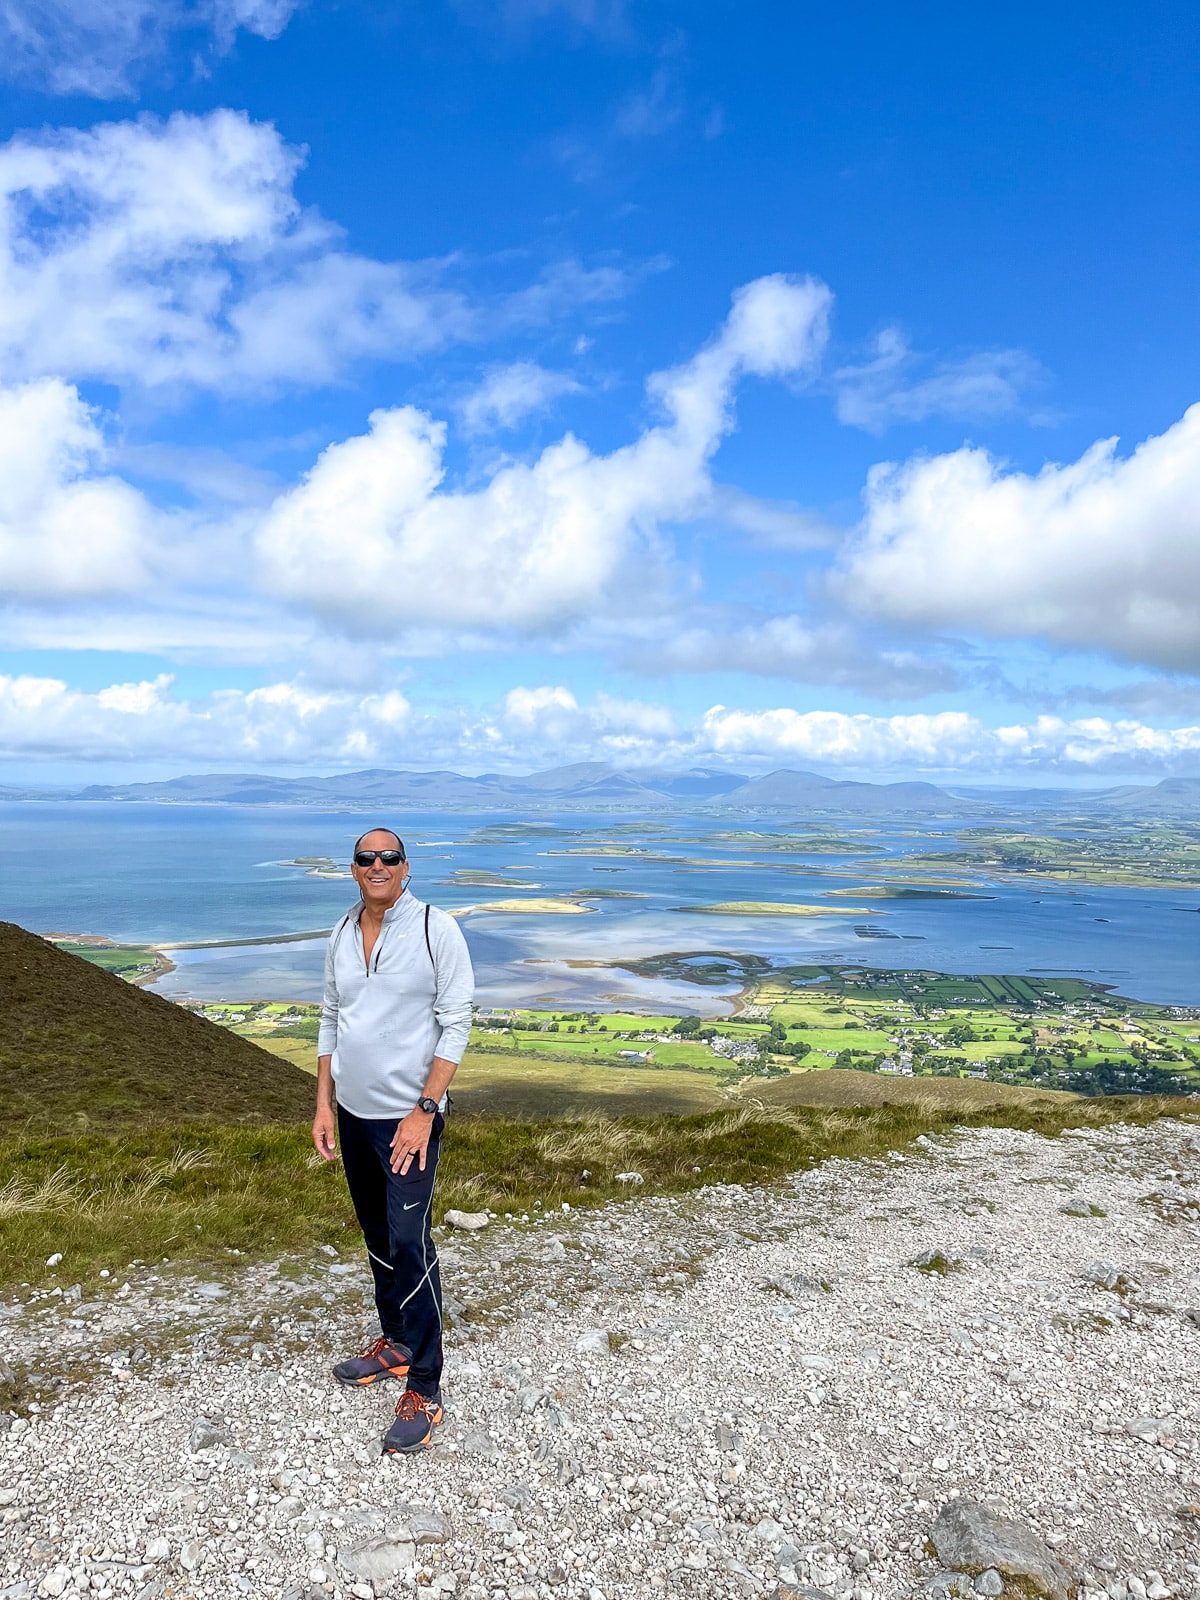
left=202, top=966, right=1200, bottom=1114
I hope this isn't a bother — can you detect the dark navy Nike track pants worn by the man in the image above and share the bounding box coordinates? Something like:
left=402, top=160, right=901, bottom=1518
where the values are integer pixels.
left=338, top=1106, right=445, bottom=1395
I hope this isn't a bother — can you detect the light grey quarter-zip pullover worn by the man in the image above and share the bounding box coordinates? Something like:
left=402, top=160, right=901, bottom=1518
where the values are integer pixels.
left=317, top=891, right=475, bottom=1118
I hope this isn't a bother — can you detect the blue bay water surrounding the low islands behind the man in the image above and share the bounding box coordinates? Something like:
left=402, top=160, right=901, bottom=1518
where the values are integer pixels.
left=0, top=802, right=1200, bottom=1013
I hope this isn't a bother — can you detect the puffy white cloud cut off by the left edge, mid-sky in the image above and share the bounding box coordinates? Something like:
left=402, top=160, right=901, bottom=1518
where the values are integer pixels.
left=0, top=378, right=166, bottom=600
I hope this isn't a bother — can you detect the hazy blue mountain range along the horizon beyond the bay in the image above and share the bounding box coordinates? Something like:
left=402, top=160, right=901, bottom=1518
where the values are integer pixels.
left=0, top=762, right=1200, bottom=818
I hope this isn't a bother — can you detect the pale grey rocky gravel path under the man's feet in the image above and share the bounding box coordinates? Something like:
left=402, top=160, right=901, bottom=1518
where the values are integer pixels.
left=0, top=1123, right=1200, bottom=1600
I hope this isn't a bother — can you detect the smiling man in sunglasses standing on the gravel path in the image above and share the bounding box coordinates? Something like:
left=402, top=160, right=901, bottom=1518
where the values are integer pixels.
left=312, top=827, right=474, bottom=1454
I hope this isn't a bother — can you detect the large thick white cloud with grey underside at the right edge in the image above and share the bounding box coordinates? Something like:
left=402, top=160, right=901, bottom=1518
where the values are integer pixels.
left=837, top=406, right=1200, bottom=672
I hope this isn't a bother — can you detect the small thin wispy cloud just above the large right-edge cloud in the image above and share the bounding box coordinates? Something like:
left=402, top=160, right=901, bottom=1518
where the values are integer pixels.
left=834, top=328, right=1043, bottom=434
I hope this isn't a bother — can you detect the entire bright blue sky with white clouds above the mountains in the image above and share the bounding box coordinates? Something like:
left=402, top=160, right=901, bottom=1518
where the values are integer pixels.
left=0, top=0, right=1200, bottom=782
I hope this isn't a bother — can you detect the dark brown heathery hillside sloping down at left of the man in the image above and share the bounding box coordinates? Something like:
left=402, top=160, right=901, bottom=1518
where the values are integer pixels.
left=0, top=922, right=312, bottom=1133
